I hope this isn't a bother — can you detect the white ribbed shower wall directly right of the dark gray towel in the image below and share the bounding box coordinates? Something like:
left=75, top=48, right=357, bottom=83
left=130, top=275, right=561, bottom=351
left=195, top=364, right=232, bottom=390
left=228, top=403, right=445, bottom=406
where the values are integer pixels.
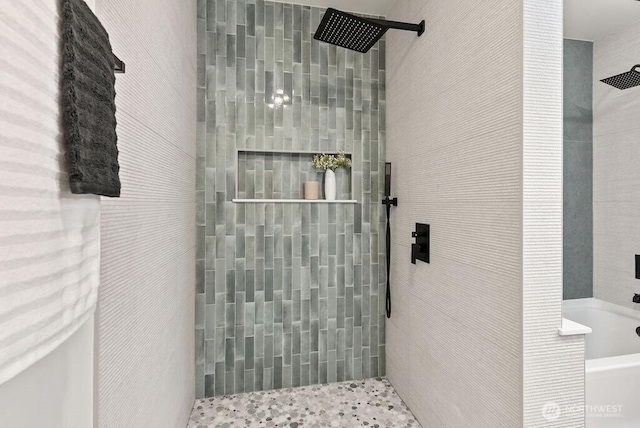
left=96, top=0, right=197, bottom=428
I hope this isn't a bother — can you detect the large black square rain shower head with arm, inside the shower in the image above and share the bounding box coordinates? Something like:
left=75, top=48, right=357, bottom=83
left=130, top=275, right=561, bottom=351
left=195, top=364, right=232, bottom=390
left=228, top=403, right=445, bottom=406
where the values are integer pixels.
left=313, top=8, right=424, bottom=53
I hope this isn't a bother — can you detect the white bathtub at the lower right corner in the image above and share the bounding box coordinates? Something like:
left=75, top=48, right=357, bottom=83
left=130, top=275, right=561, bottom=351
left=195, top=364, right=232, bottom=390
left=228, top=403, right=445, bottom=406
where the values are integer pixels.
left=562, top=296, right=640, bottom=428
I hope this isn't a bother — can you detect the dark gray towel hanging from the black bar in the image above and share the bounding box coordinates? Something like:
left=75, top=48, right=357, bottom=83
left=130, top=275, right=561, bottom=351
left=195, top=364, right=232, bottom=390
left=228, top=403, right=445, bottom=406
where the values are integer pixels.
left=61, top=0, right=120, bottom=197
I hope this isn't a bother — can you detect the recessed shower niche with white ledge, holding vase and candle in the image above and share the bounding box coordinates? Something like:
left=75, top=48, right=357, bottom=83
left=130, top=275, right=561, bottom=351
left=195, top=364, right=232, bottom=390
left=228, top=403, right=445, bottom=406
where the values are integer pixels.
left=232, top=149, right=357, bottom=204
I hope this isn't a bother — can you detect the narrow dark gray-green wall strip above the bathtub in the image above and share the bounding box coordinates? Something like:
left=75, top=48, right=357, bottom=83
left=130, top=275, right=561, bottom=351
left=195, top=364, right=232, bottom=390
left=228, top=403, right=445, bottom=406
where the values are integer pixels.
left=562, top=39, right=593, bottom=299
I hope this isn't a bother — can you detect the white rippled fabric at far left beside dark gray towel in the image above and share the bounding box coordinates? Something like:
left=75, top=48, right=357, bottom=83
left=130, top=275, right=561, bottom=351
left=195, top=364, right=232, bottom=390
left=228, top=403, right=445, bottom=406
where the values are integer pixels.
left=0, top=1, right=100, bottom=384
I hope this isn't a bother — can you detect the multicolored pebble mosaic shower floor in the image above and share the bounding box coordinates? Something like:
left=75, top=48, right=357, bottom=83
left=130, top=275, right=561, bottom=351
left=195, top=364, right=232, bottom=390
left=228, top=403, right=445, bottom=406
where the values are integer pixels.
left=187, top=378, right=420, bottom=428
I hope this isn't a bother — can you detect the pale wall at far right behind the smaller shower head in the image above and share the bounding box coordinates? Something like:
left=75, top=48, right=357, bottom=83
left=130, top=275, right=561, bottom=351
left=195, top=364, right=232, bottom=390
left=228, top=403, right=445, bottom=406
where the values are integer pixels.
left=593, top=21, right=640, bottom=307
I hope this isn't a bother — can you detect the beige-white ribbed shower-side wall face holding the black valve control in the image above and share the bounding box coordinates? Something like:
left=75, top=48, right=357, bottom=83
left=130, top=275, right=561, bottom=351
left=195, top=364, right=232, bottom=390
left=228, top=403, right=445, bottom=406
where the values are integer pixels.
left=387, top=1, right=521, bottom=426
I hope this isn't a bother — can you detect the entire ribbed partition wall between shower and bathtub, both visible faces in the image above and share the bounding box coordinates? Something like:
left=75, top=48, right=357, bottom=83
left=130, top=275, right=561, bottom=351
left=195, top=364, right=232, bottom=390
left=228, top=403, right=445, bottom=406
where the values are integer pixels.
left=386, top=0, right=584, bottom=427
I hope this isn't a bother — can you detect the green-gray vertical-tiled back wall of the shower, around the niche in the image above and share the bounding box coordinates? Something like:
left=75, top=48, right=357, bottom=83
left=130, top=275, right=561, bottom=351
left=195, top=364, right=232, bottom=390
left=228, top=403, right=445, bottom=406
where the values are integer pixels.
left=196, top=0, right=385, bottom=397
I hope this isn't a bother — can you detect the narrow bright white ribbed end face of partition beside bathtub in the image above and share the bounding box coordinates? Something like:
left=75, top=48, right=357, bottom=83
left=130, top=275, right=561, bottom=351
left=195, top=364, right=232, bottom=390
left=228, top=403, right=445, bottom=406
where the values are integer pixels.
left=522, top=0, right=584, bottom=427
